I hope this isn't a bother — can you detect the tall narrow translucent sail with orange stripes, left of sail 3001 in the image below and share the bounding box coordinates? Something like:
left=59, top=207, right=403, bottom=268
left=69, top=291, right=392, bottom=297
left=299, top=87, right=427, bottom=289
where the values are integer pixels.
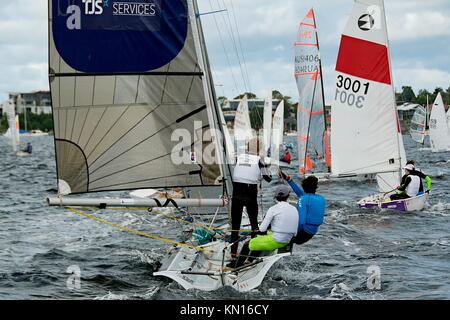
left=294, top=9, right=329, bottom=174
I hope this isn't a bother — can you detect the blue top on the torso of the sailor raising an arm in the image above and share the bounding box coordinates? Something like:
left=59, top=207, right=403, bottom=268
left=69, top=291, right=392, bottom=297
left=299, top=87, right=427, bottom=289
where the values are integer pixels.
left=297, top=193, right=325, bottom=244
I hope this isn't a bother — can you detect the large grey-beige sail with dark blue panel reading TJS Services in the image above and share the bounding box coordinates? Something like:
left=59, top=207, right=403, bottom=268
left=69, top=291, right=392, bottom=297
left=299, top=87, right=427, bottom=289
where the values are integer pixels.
left=49, top=0, right=222, bottom=193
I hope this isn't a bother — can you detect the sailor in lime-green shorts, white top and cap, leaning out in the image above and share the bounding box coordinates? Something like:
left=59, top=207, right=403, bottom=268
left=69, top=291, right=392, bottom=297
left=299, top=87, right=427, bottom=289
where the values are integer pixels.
left=227, top=185, right=298, bottom=268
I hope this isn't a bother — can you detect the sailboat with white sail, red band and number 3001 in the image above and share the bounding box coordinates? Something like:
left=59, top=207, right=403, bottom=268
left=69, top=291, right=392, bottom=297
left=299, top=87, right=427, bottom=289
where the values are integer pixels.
left=331, top=0, right=428, bottom=211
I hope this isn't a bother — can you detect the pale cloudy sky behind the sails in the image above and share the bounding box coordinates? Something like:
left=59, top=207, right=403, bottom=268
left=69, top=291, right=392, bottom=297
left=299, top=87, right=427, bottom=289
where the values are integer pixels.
left=0, top=0, right=450, bottom=102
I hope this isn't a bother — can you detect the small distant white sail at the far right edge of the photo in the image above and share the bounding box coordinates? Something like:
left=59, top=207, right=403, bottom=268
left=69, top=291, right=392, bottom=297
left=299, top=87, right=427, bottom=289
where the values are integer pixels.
left=430, top=93, right=450, bottom=152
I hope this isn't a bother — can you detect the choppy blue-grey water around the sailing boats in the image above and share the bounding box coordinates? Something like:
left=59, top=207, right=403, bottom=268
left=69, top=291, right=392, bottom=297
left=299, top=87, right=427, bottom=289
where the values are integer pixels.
left=0, top=136, right=450, bottom=300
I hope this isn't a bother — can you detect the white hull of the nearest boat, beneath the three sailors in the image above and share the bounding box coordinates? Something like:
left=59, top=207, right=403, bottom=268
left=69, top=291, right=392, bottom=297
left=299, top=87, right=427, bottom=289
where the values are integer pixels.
left=153, top=241, right=290, bottom=292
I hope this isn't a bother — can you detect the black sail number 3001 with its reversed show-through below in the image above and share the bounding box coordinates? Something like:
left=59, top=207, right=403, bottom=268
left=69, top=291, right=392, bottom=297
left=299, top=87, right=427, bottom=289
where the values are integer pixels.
left=334, top=75, right=369, bottom=108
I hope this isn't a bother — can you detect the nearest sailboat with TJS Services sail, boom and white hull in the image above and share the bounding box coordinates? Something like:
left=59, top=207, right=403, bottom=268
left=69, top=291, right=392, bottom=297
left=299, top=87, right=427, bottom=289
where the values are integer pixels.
left=47, top=0, right=290, bottom=291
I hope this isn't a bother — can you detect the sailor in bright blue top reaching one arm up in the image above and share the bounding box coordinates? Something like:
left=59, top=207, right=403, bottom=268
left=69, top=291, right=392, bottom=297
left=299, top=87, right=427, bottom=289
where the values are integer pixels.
left=279, top=170, right=326, bottom=244
